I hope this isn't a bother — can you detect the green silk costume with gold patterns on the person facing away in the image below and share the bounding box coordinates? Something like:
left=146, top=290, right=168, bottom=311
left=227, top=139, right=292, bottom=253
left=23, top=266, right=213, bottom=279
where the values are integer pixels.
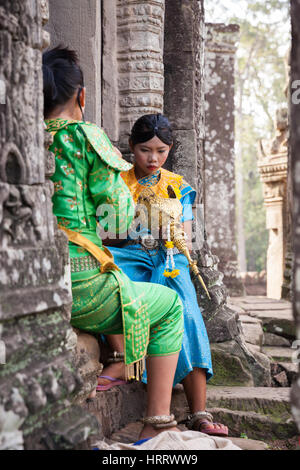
left=46, top=119, right=183, bottom=378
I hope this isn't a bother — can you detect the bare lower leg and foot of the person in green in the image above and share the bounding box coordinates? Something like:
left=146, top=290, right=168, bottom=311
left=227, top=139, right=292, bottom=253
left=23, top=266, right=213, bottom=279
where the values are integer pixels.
left=140, top=354, right=179, bottom=439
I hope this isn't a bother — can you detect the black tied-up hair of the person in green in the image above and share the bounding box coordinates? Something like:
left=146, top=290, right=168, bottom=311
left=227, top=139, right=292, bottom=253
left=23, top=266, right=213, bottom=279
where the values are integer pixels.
left=43, top=45, right=84, bottom=117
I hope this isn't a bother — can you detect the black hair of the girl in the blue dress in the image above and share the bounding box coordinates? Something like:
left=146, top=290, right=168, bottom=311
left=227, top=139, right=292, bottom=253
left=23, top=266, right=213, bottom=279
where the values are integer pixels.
left=130, top=114, right=173, bottom=146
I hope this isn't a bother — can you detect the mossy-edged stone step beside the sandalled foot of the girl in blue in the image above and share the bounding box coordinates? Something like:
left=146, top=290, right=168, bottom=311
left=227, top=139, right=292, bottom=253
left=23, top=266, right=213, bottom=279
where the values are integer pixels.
left=172, top=386, right=297, bottom=440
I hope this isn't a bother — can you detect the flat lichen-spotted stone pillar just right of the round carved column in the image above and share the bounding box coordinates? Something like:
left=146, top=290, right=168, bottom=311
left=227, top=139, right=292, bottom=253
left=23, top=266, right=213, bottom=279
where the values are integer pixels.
left=164, top=0, right=204, bottom=193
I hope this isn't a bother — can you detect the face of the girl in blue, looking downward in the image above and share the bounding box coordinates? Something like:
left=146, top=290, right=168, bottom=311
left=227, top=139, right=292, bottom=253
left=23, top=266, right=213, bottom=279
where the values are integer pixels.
left=130, top=136, right=172, bottom=178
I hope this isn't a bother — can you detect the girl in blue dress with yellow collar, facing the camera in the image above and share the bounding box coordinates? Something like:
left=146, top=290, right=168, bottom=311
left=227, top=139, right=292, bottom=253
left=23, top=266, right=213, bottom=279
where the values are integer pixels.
left=99, top=114, right=228, bottom=436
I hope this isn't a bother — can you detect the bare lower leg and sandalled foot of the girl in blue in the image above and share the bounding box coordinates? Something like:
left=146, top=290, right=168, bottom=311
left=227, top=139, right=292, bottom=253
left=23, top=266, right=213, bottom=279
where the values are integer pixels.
left=182, top=368, right=227, bottom=431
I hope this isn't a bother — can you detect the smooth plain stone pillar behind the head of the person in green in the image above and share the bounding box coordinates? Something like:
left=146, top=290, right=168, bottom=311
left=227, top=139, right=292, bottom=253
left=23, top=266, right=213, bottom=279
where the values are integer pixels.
left=47, top=0, right=102, bottom=126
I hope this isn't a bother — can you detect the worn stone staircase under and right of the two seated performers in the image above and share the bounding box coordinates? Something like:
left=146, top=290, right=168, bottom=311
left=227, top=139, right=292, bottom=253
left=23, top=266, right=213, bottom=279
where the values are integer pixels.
left=83, top=297, right=298, bottom=450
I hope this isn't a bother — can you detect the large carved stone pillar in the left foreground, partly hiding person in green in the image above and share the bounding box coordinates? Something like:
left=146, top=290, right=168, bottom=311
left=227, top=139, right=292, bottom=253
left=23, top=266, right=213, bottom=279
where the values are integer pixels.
left=0, top=0, right=95, bottom=449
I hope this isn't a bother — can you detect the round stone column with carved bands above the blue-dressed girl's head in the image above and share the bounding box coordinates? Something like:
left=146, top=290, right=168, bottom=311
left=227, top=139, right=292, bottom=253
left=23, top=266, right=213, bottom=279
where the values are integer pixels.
left=117, top=0, right=165, bottom=152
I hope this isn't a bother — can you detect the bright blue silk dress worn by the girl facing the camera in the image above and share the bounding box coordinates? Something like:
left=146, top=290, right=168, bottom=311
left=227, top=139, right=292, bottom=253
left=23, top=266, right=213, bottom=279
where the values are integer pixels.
left=109, top=173, right=213, bottom=385
